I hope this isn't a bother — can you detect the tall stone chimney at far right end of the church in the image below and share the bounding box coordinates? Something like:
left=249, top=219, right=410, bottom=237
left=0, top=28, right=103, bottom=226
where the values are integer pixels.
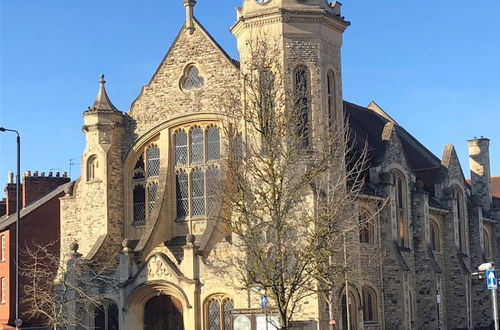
left=467, top=136, right=492, bottom=210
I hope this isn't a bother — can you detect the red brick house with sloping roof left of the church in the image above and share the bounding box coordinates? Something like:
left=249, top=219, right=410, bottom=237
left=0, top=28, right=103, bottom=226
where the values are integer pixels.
left=0, top=172, right=70, bottom=329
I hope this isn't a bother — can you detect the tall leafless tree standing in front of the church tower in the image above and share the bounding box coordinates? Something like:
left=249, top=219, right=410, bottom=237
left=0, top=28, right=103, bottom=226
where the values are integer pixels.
left=210, top=38, right=382, bottom=329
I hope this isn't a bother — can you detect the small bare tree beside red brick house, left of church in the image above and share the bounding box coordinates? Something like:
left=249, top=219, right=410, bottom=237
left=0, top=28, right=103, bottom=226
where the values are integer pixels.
left=20, top=242, right=117, bottom=329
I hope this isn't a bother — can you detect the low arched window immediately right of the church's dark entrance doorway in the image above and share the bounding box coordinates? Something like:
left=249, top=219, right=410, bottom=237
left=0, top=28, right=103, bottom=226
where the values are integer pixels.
left=204, top=295, right=234, bottom=330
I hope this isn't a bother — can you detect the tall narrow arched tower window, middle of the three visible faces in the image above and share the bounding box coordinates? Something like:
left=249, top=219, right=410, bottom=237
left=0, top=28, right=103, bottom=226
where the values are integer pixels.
left=294, top=65, right=311, bottom=147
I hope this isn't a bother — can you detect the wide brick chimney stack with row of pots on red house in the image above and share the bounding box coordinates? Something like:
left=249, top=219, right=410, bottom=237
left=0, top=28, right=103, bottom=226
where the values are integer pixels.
left=22, top=171, right=70, bottom=207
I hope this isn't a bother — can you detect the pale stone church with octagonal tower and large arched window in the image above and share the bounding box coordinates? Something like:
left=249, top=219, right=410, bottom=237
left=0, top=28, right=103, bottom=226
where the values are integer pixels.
left=56, top=0, right=500, bottom=330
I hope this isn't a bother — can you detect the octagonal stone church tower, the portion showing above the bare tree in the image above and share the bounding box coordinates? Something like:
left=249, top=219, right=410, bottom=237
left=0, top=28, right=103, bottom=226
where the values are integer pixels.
left=231, top=0, right=350, bottom=135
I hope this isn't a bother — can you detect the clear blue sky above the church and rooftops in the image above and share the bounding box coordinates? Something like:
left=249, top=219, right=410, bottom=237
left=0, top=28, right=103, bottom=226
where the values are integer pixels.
left=0, top=0, right=500, bottom=191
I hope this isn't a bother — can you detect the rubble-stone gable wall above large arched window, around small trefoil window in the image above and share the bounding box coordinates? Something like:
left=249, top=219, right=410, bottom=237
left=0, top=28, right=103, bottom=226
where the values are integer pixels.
left=124, top=21, right=240, bottom=151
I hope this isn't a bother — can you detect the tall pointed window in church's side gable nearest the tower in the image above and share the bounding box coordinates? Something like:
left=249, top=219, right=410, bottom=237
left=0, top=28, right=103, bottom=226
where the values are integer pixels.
left=392, top=170, right=409, bottom=247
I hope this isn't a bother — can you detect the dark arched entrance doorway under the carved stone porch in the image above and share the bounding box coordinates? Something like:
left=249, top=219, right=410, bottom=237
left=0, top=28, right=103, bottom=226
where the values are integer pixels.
left=144, top=294, right=184, bottom=330
